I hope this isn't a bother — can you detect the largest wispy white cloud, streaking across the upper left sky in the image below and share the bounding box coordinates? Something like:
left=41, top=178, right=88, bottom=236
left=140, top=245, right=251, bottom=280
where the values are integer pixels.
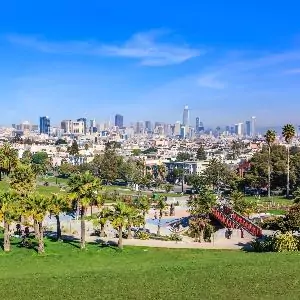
left=8, top=31, right=205, bottom=66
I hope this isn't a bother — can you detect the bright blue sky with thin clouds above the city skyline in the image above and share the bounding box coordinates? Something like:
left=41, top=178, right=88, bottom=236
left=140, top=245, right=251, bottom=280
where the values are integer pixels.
left=0, top=0, right=300, bottom=126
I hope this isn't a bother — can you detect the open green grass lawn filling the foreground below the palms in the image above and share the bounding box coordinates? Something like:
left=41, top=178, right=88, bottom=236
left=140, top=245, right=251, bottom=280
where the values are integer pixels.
left=0, top=241, right=300, bottom=300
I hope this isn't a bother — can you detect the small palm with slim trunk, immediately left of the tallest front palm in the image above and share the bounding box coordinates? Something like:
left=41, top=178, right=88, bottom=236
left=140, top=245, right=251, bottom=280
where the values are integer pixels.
left=49, top=193, right=71, bottom=241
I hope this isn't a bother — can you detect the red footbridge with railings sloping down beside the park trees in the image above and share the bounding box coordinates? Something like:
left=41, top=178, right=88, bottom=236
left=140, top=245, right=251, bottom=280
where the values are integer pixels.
left=212, top=205, right=262, bottom=237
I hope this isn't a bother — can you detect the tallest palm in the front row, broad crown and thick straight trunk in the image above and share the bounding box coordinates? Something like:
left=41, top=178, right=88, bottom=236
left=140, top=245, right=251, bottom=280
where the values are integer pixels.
left=68, top=171, right=102, bottom=249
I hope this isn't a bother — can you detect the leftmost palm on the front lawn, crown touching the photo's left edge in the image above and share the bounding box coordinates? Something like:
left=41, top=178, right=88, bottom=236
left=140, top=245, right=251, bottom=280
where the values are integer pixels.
left=0, top=191, right=18, bottom=252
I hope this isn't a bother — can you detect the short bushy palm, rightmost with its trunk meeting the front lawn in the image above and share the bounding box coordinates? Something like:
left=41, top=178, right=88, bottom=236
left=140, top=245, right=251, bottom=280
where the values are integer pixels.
left=110, top=201, right=132, bottom=249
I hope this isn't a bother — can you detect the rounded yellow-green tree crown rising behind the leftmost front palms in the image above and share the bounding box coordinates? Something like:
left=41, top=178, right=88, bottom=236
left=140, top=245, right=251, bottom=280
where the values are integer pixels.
left=10, top=163, right=36, bottom=197
